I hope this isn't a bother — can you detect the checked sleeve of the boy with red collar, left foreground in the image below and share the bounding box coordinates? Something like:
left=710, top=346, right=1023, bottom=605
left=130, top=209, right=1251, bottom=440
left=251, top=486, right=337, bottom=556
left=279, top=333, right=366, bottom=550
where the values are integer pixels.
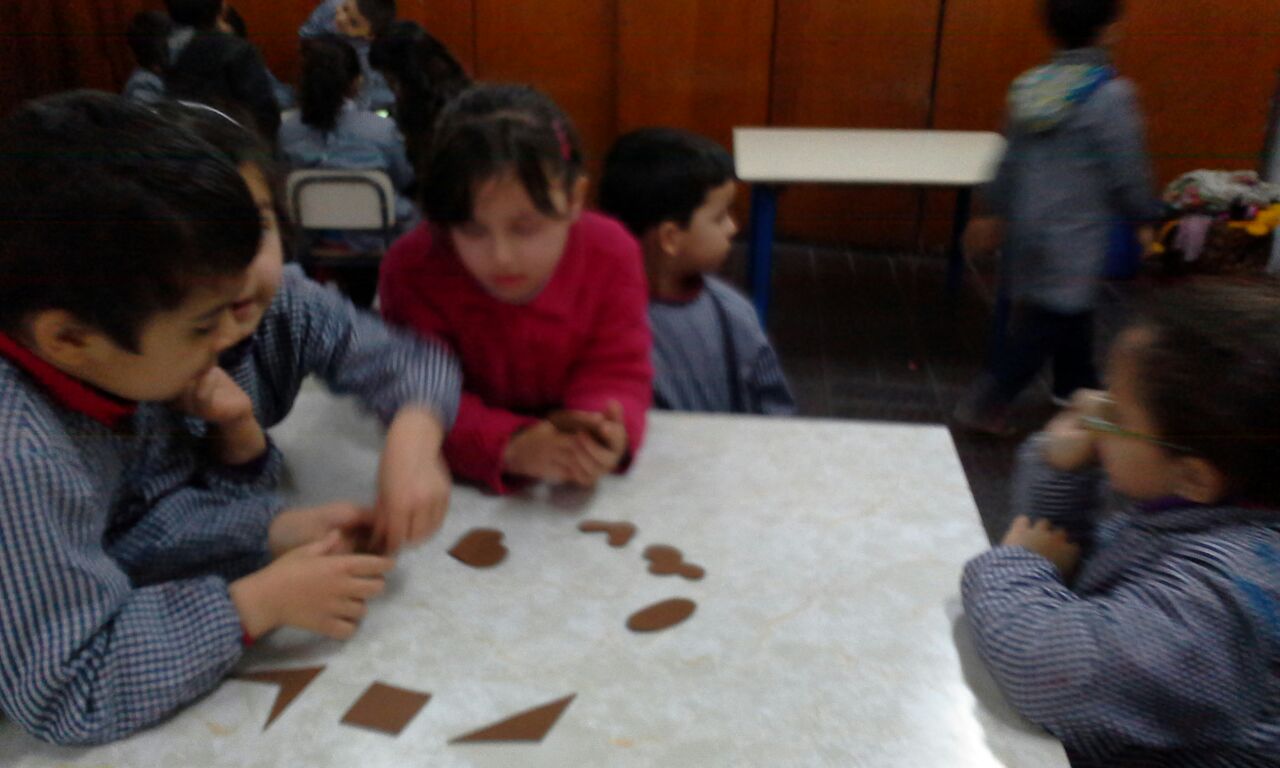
left=0, top=451, right=242, bottom=745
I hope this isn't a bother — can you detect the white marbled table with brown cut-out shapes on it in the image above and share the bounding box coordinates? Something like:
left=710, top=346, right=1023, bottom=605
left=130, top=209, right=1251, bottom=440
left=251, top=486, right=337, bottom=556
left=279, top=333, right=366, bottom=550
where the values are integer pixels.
left=0, top=387, right=1068, bottom=768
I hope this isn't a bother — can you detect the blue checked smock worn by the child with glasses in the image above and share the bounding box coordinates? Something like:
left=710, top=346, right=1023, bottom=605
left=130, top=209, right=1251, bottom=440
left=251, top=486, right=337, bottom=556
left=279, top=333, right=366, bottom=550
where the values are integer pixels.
left=961, top=439, right=1280, bottom=768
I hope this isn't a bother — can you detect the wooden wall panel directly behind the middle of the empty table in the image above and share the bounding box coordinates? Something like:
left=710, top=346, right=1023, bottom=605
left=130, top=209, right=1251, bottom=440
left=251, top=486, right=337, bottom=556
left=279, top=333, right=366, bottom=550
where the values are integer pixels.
left=771, top=0, right=940, bottom=248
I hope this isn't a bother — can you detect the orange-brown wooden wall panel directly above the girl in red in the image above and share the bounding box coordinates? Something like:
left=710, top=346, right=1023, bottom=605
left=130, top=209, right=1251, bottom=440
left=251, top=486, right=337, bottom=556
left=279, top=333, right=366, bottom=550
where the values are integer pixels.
left=475, top=0, right=617, bottom=170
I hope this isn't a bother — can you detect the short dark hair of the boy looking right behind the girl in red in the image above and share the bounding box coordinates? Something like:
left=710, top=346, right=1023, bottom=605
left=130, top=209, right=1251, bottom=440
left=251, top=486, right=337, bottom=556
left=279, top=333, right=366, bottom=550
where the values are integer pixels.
left=600, top=128, right=735, bottom=237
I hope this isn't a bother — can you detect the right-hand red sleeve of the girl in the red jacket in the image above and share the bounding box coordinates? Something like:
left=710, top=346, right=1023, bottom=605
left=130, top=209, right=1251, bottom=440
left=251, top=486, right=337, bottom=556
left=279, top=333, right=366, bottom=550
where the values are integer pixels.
left=564, top=236, right=653, bottom=460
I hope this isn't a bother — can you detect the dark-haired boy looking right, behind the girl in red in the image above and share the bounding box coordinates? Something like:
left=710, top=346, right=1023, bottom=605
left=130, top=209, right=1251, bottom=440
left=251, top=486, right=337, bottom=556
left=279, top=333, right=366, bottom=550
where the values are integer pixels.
left=600, top=128, right=795, bottom=415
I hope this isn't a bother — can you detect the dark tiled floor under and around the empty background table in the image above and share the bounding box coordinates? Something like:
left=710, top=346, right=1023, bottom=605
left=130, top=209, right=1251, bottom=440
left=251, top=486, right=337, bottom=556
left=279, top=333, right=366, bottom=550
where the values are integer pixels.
left=727, top=243, right=1129, bottom=538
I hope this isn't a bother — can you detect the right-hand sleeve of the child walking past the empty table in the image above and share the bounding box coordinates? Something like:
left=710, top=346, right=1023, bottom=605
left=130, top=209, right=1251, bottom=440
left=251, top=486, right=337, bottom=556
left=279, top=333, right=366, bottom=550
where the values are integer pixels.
left=1087, top=79, right=1161, bottom=221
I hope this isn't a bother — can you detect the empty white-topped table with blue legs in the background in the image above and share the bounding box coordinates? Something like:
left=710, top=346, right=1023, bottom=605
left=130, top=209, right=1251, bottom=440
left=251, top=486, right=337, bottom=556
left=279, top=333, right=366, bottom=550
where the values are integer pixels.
left=733, top=128, right=1005, bottom=323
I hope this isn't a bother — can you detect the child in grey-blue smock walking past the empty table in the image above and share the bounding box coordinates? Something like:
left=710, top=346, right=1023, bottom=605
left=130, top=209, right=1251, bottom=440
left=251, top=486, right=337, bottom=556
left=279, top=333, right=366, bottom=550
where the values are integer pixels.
left=955, top=0, right=1160, bottom=434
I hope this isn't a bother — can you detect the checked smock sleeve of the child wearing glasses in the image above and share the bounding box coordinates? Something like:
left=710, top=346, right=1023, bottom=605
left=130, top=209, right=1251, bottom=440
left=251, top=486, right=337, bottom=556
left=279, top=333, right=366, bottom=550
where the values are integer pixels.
left=961, top=547, right=1274, bottom=760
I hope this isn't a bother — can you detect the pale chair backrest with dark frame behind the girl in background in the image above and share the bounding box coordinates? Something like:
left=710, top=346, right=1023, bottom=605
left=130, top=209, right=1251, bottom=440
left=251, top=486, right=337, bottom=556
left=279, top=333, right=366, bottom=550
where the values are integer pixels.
left=287, top=169, right=396, bottom=233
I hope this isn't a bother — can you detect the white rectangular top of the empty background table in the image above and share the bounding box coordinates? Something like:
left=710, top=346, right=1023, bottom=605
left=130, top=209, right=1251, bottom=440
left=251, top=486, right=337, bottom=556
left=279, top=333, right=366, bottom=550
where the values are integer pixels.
left=733, top=128, right=1005, bottom=187
